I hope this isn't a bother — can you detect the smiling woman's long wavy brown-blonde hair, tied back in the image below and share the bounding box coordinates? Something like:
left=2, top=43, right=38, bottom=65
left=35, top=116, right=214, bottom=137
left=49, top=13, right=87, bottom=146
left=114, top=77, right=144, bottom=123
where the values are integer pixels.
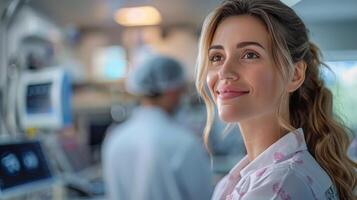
left=196, top=0, right=357, bottom=199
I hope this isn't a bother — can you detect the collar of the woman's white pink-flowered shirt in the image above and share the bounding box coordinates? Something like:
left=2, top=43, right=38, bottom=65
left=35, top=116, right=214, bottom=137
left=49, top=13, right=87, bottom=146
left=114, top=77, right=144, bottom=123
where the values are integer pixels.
left=229, top=128, right=307, bottom=178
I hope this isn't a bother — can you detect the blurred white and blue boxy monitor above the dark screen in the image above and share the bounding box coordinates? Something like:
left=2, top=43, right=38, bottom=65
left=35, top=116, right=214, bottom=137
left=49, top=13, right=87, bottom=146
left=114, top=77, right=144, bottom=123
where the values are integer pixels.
left=18, top=68, right=72, bottom=130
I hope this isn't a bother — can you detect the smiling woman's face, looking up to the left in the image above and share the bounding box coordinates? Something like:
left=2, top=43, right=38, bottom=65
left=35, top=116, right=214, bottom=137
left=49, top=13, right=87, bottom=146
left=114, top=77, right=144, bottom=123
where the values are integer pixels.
left=207, top=15, right=283, bottom=122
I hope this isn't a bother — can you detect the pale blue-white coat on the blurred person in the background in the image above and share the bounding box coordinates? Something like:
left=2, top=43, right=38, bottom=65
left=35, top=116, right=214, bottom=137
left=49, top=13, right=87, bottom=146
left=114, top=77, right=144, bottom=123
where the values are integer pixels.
left=102, top=107, right=212, bottom=200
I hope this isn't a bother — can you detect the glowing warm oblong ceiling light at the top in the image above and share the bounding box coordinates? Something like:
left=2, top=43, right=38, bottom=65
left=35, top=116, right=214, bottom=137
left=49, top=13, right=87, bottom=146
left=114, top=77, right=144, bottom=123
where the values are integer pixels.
left=114, top=6, right=161, bottom=26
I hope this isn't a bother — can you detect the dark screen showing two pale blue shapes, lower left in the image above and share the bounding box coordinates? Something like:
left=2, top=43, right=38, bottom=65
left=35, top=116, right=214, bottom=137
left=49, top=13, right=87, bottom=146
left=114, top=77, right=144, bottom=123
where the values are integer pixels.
left=0, top=141, right=52, bottom=191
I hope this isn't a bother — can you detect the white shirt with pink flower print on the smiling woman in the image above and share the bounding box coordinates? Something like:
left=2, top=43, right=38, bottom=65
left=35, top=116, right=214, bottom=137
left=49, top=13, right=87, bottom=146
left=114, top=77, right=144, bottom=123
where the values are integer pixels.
left=212, top=128, right=338, bottom=200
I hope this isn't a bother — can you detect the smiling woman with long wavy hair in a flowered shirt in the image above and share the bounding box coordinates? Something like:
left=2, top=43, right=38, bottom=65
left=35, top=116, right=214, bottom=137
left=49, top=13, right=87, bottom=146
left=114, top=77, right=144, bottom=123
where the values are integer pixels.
left=196, top=0, right=357, bottom=200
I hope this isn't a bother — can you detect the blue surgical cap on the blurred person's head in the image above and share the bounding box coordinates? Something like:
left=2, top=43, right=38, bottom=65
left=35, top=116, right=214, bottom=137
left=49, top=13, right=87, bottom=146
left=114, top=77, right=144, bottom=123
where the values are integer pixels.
left=126, top=55, right=185, bottom=96
